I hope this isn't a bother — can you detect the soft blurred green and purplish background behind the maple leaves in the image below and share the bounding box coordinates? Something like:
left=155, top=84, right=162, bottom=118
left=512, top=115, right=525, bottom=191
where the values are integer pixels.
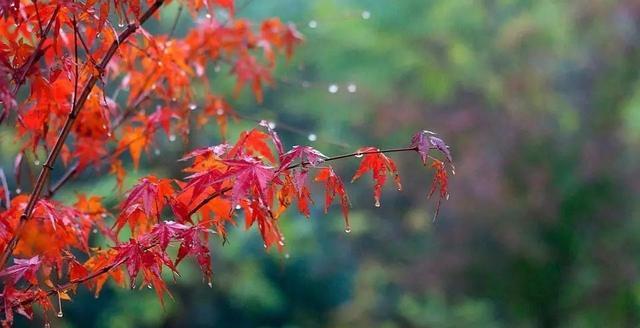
left=0, top=0, right=640, bottom=327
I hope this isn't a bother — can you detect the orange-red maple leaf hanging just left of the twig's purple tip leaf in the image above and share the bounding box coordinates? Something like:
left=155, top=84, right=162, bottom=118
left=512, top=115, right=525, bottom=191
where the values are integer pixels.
left=351, top=147, right=402, bottom=206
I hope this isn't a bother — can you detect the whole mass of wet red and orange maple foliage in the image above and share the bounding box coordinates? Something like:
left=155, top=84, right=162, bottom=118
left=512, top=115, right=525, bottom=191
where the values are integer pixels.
left=0, top=0, right=453, bottom=325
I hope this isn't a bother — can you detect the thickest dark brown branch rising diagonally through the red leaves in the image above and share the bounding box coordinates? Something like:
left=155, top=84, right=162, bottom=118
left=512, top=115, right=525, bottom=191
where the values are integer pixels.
left=0, top=0, right=164, bottom=268
